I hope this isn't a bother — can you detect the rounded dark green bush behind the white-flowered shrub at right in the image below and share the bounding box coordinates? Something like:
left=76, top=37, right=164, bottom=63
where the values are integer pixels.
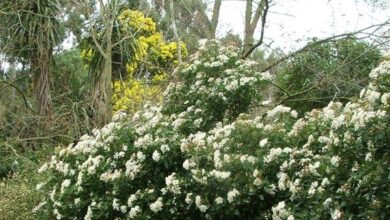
left=277, top=38, right=381, bottom=112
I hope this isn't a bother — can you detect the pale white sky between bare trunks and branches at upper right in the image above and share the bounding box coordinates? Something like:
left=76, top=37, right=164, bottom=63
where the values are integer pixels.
left=217, top=0, right=390, bottom=51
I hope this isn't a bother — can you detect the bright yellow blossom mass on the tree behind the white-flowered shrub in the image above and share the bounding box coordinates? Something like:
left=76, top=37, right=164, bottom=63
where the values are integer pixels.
left=112, top=10, right=187, bottom=112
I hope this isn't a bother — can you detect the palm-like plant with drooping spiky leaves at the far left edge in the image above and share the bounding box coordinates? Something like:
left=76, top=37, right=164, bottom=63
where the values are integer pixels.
left=0, top=0, right=63, bottom=115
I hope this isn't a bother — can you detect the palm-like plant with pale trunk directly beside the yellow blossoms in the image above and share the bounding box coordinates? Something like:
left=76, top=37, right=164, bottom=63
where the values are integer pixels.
left=80, top=0, right=137, bottom=127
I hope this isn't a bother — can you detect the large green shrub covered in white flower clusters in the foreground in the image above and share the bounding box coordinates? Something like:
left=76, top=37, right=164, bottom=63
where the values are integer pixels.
left=35, top=41, right=390, bottom=220
